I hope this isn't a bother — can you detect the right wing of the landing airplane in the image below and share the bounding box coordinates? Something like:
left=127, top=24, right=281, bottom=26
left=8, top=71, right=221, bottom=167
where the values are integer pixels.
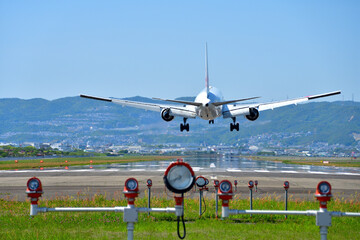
left=223, top=91, right=341, bottom=118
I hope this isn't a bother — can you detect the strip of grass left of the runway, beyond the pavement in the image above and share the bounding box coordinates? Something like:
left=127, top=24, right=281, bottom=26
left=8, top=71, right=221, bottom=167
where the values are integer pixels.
left=0, top=156, right=178, bottom=170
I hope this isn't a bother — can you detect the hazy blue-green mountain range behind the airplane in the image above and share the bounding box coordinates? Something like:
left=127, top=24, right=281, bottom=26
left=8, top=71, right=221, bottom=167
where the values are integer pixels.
left=0, top=96, right=360, bottom=146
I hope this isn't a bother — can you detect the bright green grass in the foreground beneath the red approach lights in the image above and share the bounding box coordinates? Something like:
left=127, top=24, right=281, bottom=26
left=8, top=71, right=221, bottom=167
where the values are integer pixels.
left=0, top=194, right=360, bottom=240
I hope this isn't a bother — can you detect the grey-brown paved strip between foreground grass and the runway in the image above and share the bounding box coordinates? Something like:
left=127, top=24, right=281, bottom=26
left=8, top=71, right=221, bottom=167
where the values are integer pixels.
left=0, top=170, right=360, bottom=201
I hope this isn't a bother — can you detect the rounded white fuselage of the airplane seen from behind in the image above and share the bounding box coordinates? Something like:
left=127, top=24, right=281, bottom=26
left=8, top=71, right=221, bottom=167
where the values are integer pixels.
left=195, top=87, right=223, bottom=120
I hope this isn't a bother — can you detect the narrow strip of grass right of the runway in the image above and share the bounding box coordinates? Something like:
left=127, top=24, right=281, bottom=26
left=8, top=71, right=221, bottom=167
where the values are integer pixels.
left=249, top=156, right=360, bottom=167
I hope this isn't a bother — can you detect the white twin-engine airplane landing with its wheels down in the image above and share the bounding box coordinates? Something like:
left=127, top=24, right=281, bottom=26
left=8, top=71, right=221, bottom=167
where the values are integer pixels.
left=80, top=44, right=341, bottom=132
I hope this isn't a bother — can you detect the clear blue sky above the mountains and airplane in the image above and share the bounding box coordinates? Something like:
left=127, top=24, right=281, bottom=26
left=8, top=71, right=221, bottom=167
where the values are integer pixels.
left=0, top=0, right=360, bottom=101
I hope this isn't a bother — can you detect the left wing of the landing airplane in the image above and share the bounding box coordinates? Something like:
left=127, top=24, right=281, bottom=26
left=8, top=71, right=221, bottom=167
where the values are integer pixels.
left=80, top=94, right=196, bottom=118
